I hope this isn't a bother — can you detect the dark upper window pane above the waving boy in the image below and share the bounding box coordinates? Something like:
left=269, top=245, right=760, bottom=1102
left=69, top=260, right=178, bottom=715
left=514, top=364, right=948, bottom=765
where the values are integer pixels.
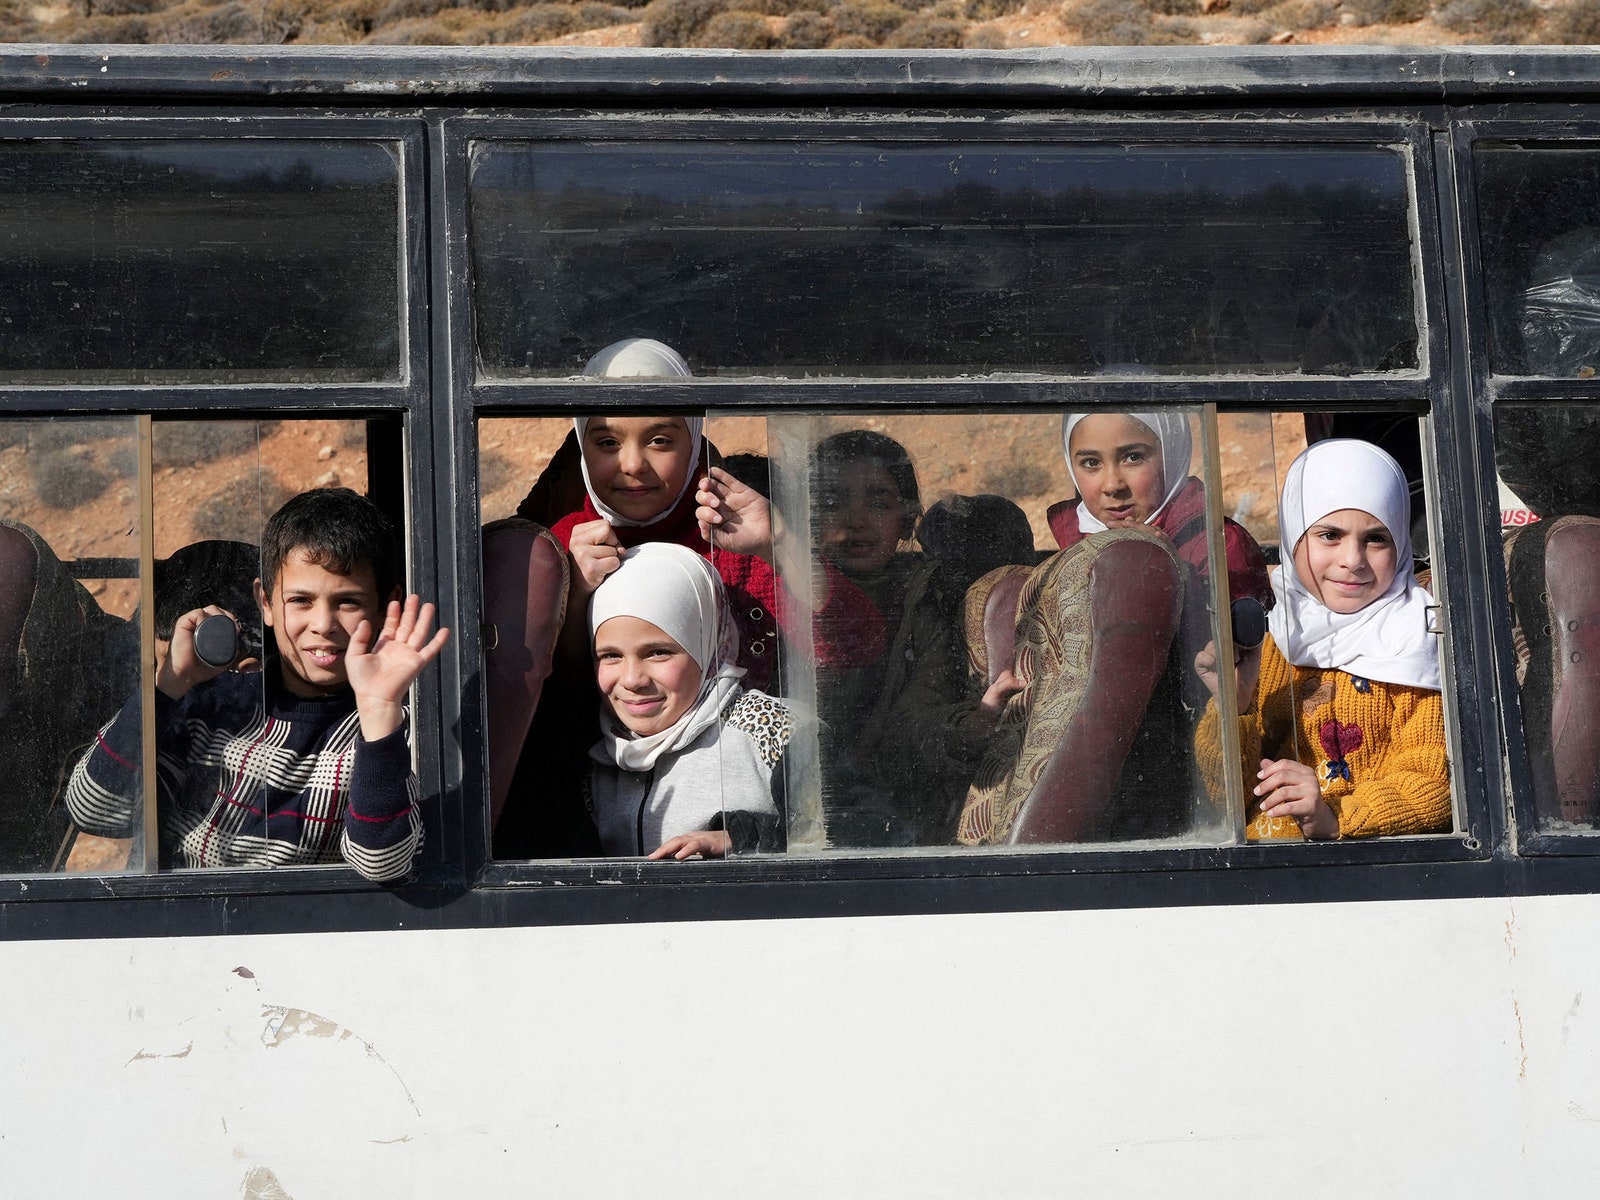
left=0, top=138, right=405, bottom=384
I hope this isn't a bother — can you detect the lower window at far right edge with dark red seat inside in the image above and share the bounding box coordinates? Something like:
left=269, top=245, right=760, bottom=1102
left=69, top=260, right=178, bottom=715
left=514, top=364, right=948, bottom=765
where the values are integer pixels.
left=1494, top=403, right=1600, bottom=832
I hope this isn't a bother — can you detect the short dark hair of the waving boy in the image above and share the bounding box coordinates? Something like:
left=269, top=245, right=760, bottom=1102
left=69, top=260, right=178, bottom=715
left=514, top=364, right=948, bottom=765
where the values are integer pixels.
left=261, top=488, right=400, bottom=602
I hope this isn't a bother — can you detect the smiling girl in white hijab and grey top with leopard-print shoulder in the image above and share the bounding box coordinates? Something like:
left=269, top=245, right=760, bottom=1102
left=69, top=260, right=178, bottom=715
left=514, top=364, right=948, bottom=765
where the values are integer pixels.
left=589, top=542, right=794, bottom=859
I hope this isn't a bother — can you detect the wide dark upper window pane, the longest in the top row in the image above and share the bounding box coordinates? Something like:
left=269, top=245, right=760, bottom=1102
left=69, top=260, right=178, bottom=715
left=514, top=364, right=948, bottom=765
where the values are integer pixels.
left=469, top=139, right=1419, bottom=379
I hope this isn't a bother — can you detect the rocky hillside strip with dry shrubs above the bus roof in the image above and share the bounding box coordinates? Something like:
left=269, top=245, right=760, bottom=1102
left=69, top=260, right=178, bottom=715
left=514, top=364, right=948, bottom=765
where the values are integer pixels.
left=9, top=0, right=1600, bottom=50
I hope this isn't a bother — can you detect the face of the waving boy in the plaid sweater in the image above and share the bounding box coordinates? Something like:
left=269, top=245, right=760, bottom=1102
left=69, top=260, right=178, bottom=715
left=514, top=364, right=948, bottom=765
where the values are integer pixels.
left=256, top=550, right=384, bottom=698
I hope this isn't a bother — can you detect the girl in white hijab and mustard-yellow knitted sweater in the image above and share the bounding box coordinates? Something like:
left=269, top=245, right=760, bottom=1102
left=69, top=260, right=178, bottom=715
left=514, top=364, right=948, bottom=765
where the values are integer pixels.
left=1195, top=438, right=1451, bottom=842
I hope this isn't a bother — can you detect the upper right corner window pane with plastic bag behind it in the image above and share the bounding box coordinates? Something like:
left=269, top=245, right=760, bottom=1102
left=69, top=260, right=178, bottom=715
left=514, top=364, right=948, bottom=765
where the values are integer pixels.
left=1472, top=142, right=1600, bottom=379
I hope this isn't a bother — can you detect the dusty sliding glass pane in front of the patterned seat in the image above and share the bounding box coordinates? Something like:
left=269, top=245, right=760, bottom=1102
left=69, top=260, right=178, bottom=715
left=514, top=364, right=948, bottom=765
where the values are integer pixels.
left=742, top=410, right=1228, bottom=853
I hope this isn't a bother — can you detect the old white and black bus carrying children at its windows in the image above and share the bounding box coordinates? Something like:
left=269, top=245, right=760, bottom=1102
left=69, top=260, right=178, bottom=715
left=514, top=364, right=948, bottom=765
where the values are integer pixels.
left=0, top=45, right=1600, bottom=1200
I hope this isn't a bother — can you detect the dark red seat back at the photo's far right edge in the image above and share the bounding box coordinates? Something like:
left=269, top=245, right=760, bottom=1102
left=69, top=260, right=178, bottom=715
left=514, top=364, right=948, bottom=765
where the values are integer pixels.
left=1509, top=517, right=1600, bottom=826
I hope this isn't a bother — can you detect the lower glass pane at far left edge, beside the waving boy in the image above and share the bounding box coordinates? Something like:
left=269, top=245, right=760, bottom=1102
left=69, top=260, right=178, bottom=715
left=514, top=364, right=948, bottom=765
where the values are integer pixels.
left=0, top=418, right=141, bottom=874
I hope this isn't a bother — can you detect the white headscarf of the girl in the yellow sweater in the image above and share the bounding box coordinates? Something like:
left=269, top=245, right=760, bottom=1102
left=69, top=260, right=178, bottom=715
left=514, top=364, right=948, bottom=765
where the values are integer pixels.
left=1267, top=438, right=1440, bottom=691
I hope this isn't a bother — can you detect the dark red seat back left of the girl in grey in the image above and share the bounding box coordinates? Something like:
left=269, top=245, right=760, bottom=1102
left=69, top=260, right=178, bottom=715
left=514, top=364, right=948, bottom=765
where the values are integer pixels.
left=483, top=517, right=568, bottom=824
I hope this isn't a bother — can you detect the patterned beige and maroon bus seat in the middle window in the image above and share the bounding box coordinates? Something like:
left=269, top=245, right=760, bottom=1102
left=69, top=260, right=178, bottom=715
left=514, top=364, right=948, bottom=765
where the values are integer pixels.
left=958, top=528, right=1187, bottom=845
